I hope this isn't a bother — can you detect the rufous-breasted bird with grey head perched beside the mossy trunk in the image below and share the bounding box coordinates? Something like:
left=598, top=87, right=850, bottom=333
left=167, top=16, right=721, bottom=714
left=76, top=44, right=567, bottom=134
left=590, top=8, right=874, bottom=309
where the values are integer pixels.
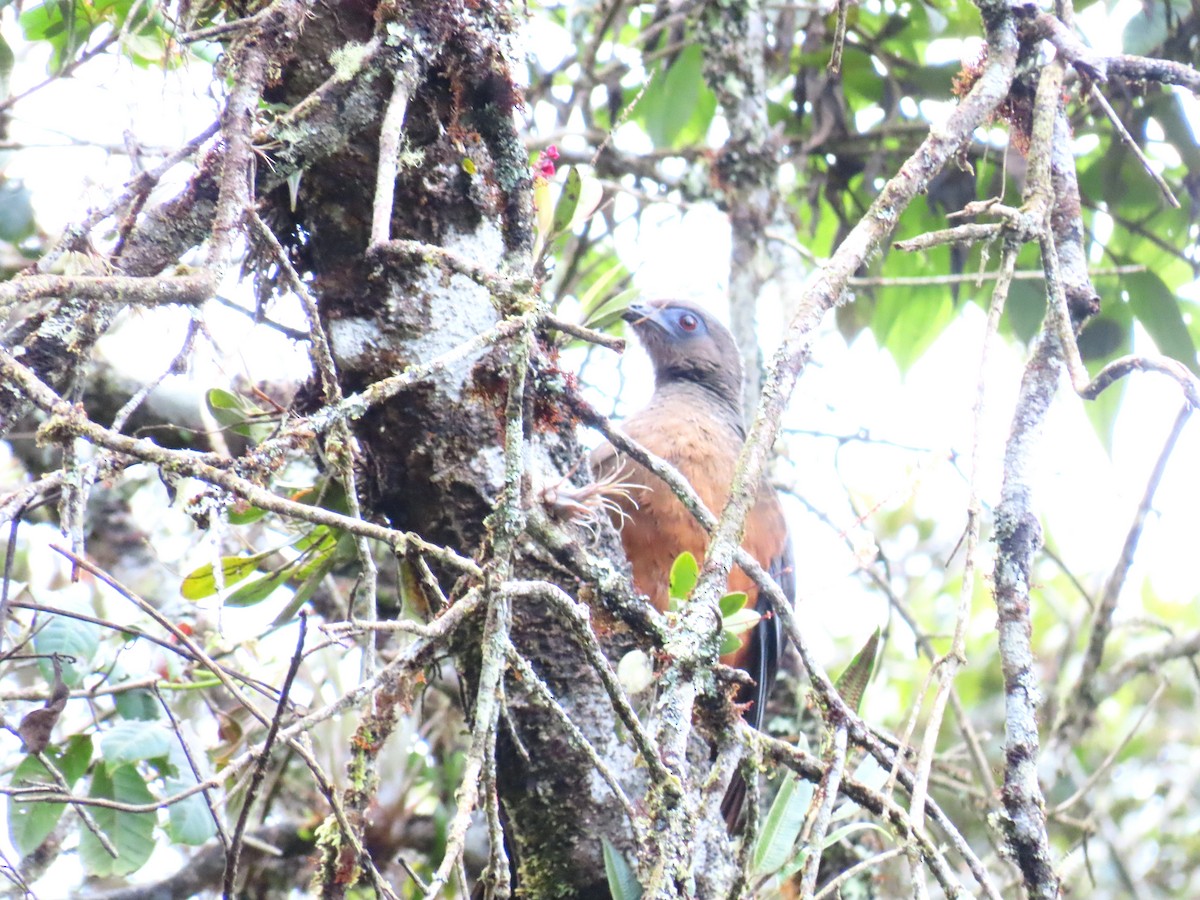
left=590, top=300, right=796, bottom=829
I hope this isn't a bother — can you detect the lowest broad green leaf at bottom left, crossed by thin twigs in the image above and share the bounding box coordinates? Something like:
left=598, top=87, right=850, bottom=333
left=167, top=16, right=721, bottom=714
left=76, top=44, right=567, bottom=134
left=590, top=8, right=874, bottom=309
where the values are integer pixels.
left=79, top=766, right=157, bottom=877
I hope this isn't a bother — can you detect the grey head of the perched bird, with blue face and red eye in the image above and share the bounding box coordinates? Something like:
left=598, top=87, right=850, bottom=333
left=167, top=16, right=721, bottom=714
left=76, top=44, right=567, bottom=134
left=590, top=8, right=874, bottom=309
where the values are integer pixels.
left=622, top=300, right=742, bottom=419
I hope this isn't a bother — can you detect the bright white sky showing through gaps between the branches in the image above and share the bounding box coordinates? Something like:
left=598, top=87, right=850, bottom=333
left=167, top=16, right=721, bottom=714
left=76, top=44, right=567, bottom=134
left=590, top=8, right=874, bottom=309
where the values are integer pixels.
left=0, top=0, right=1200, bottom=888
